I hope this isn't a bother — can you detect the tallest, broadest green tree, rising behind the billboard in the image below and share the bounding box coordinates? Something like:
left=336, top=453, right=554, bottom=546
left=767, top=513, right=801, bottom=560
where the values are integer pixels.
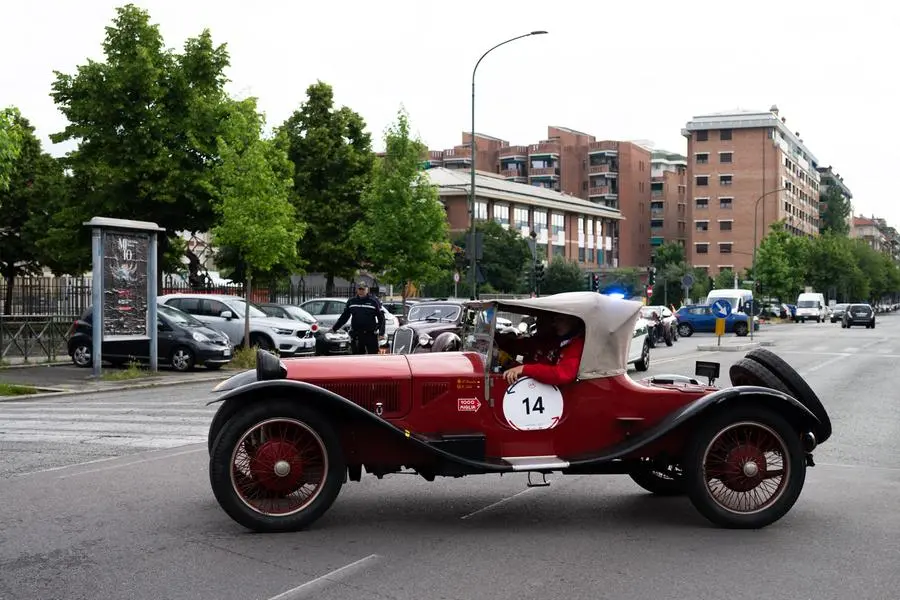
left=47, top=4, right=235, bottom=278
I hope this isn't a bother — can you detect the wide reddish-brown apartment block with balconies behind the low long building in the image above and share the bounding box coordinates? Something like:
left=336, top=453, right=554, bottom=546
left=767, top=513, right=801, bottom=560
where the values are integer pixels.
left=428, top=126, right=651, bottom=268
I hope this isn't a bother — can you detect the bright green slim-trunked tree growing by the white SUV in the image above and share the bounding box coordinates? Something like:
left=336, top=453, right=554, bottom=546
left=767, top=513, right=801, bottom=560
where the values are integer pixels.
left=212, top=106, right=306, bottom=347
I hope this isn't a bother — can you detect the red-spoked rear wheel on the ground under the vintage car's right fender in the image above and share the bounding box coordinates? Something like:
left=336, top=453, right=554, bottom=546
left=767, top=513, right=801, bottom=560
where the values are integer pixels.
left=685, top=406, right=806, bottom=529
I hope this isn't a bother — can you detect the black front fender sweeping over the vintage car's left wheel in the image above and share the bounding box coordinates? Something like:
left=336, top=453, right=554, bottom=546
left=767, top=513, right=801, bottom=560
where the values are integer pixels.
left=207, top=374, right=510, bottom=472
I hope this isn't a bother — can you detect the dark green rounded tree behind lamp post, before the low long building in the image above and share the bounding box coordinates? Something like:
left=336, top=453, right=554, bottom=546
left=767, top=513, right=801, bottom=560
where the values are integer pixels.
left=453, top=221, right=532, bottom=295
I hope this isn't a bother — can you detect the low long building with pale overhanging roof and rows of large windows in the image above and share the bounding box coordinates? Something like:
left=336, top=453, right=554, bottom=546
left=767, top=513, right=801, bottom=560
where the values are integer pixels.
left=427, top=167, right=622, bottom=270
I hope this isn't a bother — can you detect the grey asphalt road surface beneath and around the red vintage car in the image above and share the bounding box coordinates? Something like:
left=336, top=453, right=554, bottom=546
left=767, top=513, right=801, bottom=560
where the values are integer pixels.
left=0, top=315, right=900, bottom=600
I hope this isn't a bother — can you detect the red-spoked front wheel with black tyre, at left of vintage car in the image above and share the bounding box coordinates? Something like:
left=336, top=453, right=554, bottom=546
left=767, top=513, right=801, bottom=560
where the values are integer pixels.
left=210, top=401, right=345, bottom=532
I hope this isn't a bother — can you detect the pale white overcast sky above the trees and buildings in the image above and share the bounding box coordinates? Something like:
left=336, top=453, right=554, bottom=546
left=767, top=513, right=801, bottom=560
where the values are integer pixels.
left=0, top=0, right=900, bottom=228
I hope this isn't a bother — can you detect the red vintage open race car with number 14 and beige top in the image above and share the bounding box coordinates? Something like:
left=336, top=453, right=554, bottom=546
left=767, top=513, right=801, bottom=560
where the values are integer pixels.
left=209, top=292, right=831, bottom=532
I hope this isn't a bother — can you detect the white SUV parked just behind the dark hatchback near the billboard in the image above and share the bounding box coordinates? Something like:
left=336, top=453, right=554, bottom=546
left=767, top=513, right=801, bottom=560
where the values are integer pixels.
left=158, top=294, right=316, bottom=356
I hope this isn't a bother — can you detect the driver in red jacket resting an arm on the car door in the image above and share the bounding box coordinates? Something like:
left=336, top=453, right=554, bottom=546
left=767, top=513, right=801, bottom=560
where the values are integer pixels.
left=503, top=314, right=584, bottom=385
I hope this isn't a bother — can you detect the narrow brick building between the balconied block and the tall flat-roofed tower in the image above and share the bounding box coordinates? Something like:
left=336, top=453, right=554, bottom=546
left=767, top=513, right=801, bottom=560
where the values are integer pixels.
left=650, top=150, right=691, bottom=251
